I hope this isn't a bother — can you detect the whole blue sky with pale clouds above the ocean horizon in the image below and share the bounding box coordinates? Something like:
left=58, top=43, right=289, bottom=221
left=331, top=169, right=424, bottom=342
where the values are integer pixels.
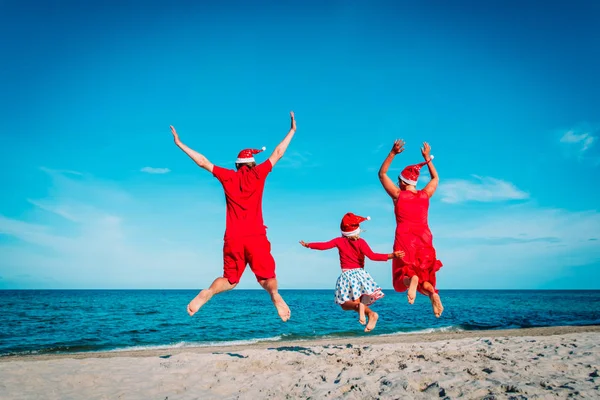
left=0, top=1, right=600, bottom=289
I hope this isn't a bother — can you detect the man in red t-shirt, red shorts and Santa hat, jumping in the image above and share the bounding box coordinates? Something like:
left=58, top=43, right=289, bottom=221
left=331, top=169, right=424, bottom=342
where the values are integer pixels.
left=171, top=112, right=296, bottom=322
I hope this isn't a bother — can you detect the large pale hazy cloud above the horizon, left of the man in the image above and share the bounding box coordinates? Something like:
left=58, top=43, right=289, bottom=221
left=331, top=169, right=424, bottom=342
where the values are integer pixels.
left=0, top=170, right=224, bottom=288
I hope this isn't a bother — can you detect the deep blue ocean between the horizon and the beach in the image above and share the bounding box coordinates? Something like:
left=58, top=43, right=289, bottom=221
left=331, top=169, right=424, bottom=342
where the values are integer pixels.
left=0, top=290, right=600, bottom=356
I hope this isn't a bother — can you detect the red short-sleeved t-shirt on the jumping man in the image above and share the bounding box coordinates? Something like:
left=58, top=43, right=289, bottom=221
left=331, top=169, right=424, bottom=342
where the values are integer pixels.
left=213, top=160, right=273, bottom=240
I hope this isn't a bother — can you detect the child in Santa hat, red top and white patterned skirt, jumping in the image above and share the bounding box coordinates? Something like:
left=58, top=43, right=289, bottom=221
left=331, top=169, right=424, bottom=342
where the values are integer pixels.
left=300, top=213, right=404, bottom=332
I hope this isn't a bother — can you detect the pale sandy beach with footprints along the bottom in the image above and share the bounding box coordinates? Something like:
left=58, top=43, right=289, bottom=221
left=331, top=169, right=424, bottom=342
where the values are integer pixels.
left=0, top=326, right=600, bottom=400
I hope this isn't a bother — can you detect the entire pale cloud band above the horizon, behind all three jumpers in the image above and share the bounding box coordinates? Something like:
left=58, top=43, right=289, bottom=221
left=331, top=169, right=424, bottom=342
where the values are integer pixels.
left=0, top=171, right=600, bottom=289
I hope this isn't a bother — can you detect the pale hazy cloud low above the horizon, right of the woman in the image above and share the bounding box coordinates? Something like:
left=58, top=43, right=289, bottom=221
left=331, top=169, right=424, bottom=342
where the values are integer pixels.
left=432, top=204, right=600, bottom=289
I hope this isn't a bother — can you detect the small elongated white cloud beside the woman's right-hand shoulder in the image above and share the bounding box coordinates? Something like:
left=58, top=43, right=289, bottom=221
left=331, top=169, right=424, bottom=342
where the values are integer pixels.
left=438, top=175, right=529, bottom=203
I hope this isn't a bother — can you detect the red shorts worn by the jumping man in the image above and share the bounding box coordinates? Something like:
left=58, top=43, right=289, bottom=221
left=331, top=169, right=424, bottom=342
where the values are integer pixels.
left=223, top=235, right=275, bottom=285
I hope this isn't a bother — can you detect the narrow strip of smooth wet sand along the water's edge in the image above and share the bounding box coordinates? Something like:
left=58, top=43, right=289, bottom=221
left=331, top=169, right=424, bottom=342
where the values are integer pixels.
left=0, top=325, right=600, bottom=363
